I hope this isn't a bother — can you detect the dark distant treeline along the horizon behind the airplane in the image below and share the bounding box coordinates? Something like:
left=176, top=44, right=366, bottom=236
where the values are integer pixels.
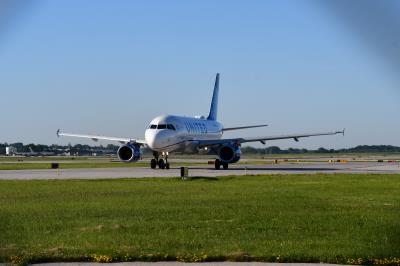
left=0, top=142, right=400, bottom=155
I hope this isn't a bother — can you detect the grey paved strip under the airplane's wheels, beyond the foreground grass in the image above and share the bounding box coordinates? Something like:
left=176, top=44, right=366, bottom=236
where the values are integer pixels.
left=0, top=162, right=400, bottom=180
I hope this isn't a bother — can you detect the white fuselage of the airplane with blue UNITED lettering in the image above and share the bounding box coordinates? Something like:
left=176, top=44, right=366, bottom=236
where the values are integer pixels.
left=145, top=115, right=223, bottom=153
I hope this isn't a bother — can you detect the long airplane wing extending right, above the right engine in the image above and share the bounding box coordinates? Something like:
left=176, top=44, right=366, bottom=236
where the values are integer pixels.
left=199, top=130, right=344, bottom=148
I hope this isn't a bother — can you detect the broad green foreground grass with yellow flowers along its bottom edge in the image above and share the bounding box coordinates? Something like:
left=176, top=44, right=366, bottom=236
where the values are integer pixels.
left=0, top=174, right=400, bottom=265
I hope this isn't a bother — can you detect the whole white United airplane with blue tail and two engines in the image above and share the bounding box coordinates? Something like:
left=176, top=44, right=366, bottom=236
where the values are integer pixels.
left=57, top=73, right=344, bottom=170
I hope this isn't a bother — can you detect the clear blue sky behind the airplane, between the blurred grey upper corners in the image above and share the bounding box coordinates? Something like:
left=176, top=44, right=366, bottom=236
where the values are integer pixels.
left=0, top=0, right=400, bottom=148
